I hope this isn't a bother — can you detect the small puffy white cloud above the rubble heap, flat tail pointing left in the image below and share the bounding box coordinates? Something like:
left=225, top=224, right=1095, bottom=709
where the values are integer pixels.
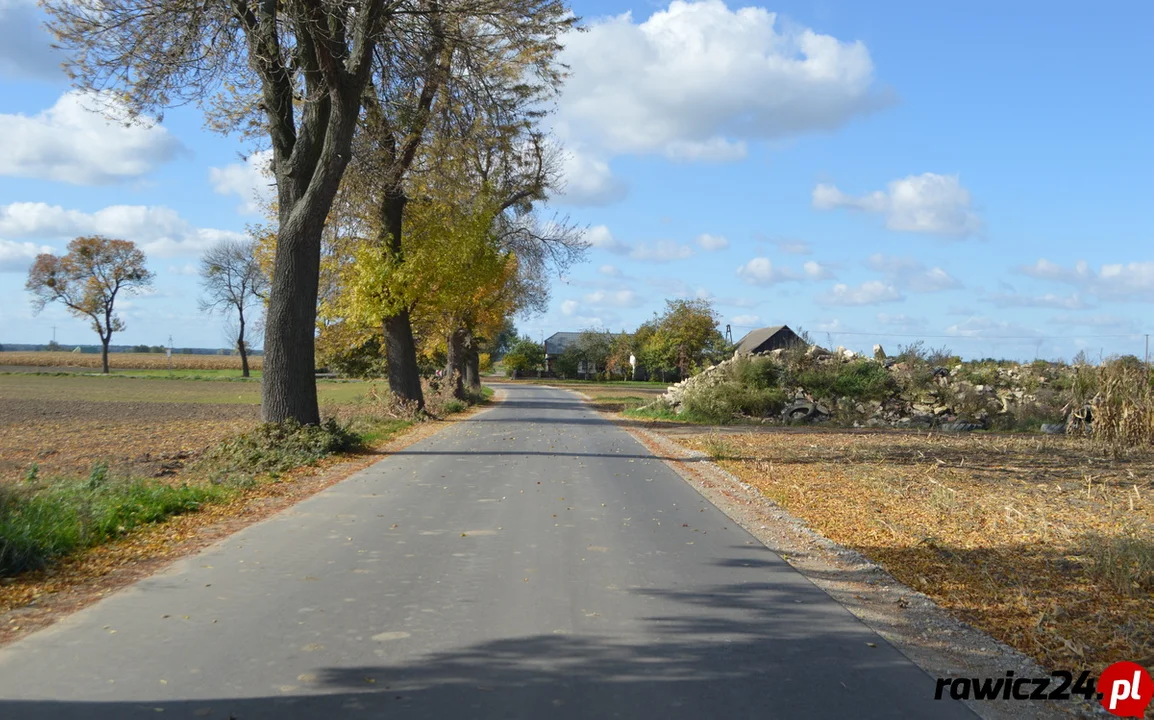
left=814, top=173, right=982, bottom=238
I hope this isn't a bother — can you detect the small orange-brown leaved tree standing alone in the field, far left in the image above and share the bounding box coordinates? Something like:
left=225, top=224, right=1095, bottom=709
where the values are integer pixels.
left=24, top=237, right=152, bottom=374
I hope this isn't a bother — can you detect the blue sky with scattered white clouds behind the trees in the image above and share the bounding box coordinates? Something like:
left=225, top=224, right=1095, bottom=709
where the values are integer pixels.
left=0, top=0, right=1154, bottom=359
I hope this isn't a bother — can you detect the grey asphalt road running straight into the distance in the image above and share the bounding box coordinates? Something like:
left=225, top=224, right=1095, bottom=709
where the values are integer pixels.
left=0, top=385, right=972, bottom=720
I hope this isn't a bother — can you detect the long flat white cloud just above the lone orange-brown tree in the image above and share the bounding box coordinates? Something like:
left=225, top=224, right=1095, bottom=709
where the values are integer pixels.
left=0, top=203, right=245, bottom=257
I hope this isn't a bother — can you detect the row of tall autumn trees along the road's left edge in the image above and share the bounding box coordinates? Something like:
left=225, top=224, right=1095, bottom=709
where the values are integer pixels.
left=30, top=0, right=585, bottom=413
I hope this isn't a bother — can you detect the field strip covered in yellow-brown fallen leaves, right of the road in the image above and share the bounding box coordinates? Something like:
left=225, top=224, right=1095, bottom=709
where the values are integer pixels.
left=674, top=430, right=1154, bottom=673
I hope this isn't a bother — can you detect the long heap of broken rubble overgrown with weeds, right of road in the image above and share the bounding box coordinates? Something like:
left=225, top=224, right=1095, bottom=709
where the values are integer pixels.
left=658, top=345, right=1088, bottom=433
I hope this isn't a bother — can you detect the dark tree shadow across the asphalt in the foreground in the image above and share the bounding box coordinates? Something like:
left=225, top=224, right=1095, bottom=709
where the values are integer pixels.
left=0, top=546, right=973, bottom=720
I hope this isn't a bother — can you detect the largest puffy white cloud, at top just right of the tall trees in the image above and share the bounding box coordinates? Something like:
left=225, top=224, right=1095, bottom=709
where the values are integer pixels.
left=556, top=0, right=881, bottom=160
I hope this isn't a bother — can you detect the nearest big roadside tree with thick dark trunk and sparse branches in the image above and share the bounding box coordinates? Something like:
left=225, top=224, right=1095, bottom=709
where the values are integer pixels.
left=44, top=0, right=383, bottom=423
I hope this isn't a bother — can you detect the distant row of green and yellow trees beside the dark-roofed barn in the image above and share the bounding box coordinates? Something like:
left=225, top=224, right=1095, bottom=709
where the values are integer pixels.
left=504, top=300, right=733, bottom=381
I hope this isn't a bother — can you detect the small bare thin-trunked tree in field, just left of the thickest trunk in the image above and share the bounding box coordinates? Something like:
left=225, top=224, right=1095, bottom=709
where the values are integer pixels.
left=200, top=240, right=269, bottom=377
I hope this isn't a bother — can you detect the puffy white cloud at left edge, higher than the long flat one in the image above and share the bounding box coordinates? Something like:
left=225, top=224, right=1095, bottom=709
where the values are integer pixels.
left=0, top=90, right=181, bottom=185
